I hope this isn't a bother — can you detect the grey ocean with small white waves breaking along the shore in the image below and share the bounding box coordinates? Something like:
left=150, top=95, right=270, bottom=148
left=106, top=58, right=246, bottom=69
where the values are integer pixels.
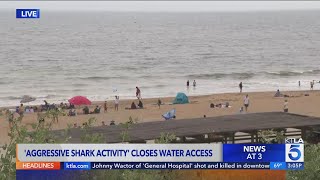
left=0, top=11, right=320, bottom=106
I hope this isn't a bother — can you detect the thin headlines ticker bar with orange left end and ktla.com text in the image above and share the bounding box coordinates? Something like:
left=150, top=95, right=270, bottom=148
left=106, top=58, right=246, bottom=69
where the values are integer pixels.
left=17, top=162, right=304, bottom=170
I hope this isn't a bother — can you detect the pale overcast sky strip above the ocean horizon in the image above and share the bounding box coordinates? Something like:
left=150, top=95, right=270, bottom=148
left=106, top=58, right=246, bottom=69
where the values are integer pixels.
left=0, top=1, right=320, bottom=12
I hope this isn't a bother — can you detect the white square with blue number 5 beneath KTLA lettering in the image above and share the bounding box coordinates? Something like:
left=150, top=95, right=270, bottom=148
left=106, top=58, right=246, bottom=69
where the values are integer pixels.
left=286, top=141, right=304, bottom=162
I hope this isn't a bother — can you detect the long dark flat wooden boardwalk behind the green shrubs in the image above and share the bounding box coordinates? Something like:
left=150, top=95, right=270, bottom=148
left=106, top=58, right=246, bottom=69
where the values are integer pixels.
left=55, top=112, right=320, bottom=143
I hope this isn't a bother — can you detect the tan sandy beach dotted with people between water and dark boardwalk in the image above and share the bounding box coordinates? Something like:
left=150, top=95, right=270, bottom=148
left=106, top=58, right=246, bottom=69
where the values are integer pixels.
left=0, top=91, right=320, bottom=144
